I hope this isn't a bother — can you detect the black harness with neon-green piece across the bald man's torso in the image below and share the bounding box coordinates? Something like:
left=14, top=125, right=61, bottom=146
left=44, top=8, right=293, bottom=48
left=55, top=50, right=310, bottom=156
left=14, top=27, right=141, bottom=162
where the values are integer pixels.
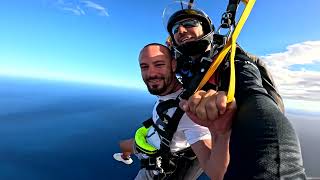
left=135, top=99, right=196, bottom=179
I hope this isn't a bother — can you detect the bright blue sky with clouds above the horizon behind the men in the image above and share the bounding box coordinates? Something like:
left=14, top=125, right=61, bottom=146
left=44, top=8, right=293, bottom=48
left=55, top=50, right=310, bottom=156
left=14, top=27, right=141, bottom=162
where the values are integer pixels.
left=0, top=0, right=320, bottom=112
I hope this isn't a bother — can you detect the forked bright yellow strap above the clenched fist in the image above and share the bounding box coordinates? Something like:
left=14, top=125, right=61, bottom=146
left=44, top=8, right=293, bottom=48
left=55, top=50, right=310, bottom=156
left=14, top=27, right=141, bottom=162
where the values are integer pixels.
left=195, top=0, right=256, bottom=103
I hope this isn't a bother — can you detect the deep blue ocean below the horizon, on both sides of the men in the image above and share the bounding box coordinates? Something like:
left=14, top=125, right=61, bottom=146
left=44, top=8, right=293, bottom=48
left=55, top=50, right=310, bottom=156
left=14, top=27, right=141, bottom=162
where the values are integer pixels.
left=0, top=77, right=320, bottom=180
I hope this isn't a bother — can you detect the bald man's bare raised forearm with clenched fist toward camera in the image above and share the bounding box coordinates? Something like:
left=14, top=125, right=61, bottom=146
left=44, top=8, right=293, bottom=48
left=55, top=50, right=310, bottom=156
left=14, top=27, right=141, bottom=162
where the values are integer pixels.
left=181, top=91, right=236, bottom=180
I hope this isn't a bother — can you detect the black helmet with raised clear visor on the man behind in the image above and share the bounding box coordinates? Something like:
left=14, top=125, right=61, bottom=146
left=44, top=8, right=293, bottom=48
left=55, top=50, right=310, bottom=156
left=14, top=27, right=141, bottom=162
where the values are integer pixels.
left=163, top=1, right=214, bottom=56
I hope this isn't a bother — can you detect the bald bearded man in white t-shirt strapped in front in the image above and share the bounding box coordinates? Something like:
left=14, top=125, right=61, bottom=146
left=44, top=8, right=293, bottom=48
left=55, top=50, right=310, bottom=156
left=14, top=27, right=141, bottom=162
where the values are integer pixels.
left=115, top=43, right=235, bottom=180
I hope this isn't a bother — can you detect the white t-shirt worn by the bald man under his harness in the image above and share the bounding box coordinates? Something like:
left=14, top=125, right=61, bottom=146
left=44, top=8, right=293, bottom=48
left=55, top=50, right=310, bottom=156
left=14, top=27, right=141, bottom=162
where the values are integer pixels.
left=146, top=89, right=211, bottom=152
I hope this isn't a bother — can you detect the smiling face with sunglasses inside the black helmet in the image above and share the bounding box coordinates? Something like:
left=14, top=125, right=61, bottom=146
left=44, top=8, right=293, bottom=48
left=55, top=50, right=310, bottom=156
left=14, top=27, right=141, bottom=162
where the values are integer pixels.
left=173, top=19, right=203, bottom=45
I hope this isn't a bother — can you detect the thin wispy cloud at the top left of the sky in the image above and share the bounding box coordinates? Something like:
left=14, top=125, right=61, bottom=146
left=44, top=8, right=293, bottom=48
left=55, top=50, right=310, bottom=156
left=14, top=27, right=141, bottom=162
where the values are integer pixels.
left=55, top=0, right=109, bottom=17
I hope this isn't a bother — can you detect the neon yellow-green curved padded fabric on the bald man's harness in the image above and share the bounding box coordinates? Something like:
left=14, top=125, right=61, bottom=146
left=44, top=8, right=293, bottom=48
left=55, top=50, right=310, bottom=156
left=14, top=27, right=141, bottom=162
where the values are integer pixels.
left=134, top=126, right=157, bottom=154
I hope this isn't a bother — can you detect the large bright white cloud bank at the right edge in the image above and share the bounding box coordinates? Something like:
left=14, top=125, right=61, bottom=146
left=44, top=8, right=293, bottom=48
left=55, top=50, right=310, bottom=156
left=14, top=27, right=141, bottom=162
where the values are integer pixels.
left=262, top=41, right=320, bottom=102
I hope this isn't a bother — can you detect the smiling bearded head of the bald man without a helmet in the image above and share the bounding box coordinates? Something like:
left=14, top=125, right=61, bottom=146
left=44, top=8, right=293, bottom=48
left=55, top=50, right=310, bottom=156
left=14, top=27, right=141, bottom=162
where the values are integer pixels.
left=139, top=45, right=176, bottom=95
